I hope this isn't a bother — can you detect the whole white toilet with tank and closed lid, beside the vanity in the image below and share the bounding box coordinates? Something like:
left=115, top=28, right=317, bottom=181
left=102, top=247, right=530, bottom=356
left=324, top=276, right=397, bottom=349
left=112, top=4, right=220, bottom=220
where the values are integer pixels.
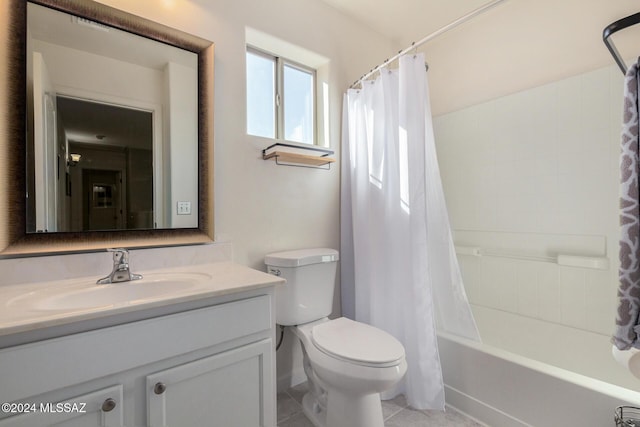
left=264, top=248, right=407, bottom=427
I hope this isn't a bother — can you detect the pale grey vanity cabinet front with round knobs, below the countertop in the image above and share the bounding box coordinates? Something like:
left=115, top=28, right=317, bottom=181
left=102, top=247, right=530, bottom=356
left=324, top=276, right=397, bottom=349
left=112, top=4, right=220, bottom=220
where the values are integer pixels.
left=0, top=287, right=276, bottom=427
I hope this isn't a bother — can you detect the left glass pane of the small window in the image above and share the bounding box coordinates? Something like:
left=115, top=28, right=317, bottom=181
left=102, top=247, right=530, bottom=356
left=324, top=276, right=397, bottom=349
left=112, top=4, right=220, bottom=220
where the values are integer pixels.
left=247, top=52, right=276, bottom=138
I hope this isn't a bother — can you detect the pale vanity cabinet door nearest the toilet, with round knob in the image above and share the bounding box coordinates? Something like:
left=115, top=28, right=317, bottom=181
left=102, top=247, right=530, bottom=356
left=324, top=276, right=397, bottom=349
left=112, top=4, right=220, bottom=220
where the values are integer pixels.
left=147, top=339, right=275, bottom=427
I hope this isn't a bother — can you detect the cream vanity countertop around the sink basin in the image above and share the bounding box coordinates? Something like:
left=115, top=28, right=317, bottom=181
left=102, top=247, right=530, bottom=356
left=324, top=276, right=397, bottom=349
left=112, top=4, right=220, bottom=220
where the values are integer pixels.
left=0, top=262, right=284, bottom=338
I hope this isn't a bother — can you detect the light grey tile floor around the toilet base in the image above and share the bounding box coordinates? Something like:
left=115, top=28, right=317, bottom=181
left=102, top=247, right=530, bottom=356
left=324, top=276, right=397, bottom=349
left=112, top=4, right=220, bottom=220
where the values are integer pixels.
left=278, top=384, right=483, bottom=427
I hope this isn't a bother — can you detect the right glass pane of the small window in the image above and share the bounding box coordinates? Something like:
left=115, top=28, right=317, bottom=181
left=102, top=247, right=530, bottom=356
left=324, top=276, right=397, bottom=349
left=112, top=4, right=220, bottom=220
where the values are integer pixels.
left=284, top=65, right=314, bottom=144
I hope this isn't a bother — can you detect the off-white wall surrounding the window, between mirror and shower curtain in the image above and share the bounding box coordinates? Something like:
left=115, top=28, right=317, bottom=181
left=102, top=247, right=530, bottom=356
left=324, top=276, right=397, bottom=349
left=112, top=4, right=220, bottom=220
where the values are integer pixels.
left=93, top=0, right=391, bottom=268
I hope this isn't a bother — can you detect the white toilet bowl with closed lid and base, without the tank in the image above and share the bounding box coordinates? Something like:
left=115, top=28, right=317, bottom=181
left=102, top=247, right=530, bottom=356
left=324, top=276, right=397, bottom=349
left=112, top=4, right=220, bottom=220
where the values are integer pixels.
left=293, top=317, right=407, bottom=427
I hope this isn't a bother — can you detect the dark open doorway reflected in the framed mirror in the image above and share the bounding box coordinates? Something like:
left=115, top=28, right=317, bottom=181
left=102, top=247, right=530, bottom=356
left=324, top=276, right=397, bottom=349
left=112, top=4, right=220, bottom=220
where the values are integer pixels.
left=57, top=95, right=154, bottom=231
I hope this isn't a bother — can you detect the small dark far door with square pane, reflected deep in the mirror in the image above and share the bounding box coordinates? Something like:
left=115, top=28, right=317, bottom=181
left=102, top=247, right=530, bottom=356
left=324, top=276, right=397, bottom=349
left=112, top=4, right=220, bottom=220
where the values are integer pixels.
left=82, top=169, right=123, bottom=230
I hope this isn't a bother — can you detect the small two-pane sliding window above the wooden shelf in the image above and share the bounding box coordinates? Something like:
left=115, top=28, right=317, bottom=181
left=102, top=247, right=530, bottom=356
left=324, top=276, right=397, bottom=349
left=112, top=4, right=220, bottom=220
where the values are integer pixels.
left=247, top=47, right=316, bottom=144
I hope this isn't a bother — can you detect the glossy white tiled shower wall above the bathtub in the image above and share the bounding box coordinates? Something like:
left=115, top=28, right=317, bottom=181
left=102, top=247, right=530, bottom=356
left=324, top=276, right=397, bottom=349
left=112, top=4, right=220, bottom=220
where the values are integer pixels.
left=434, top=66, right=623, bottom=334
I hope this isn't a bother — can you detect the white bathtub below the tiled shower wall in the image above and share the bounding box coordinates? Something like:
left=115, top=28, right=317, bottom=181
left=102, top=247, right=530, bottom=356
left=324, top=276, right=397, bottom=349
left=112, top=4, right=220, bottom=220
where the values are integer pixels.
left=438, top=306, right=640, bottom=427
